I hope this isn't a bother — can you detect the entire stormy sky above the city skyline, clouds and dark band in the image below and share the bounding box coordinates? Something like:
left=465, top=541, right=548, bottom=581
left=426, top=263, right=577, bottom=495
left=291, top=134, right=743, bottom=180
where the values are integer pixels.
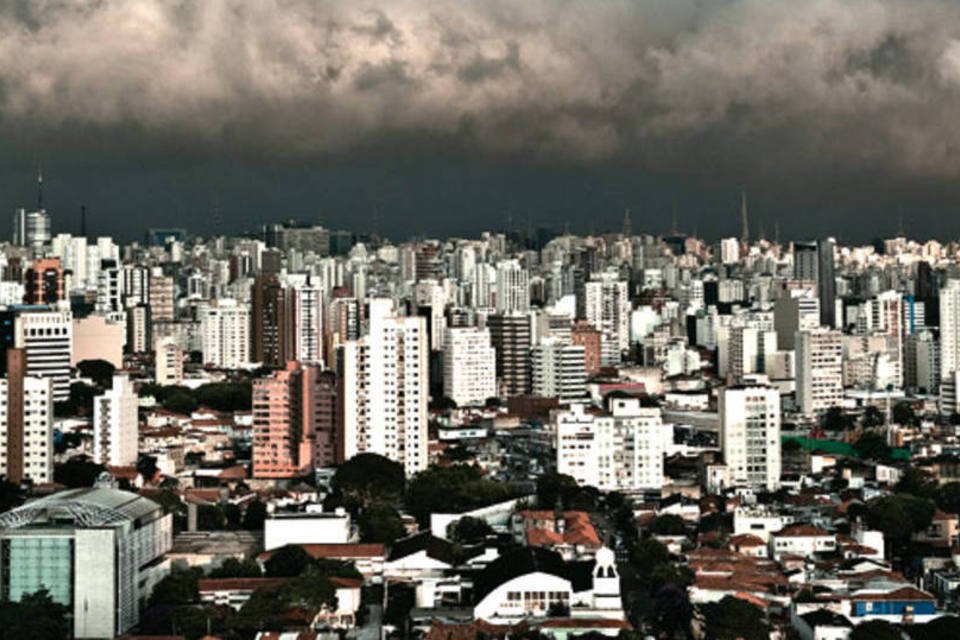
left=0, top=0, right=960, bottom=240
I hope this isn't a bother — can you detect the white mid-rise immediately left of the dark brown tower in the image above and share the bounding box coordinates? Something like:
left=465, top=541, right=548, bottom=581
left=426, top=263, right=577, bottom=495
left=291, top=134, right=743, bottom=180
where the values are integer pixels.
left=199, top=298, right=250, bottom=369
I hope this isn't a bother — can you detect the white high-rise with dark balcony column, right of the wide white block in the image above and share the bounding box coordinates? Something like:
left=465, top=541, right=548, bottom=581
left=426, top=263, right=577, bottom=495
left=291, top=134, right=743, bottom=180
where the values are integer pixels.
left=719, top=386, right=781, bottom=491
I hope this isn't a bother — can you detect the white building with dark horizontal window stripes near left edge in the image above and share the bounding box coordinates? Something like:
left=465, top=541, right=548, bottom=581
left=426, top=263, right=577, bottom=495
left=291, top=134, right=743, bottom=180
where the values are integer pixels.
left=14, top=309, right=73, bottom=402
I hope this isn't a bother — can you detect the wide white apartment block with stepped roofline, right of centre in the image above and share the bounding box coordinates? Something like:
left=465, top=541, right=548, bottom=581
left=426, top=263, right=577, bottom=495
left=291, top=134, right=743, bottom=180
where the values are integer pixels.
left=556, top=398, right=673, bottom=491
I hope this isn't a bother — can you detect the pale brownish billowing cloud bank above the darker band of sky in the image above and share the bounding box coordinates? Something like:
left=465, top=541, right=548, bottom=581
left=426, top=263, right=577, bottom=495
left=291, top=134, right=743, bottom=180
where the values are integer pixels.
left=0, top=0, right=960, bottom=178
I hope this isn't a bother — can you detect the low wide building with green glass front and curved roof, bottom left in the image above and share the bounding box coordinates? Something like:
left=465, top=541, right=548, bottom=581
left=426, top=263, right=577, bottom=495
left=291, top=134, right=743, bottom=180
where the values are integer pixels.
left=0, top=488, right=173, bottom=638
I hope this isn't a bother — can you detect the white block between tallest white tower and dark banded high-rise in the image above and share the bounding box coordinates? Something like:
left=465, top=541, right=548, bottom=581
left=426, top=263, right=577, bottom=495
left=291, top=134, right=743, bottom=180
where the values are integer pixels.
left=443, top=327, right=497, bottom=407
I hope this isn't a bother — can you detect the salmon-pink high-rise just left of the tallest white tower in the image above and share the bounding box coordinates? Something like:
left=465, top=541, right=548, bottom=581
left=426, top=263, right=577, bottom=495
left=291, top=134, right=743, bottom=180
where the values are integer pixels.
left=253, top=361, right=336, bottom=478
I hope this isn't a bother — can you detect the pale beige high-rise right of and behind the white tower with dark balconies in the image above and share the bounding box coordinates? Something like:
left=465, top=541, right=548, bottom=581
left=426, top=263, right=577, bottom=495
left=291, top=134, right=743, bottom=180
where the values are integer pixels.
left=796, top=328, right=843, bottom=415
